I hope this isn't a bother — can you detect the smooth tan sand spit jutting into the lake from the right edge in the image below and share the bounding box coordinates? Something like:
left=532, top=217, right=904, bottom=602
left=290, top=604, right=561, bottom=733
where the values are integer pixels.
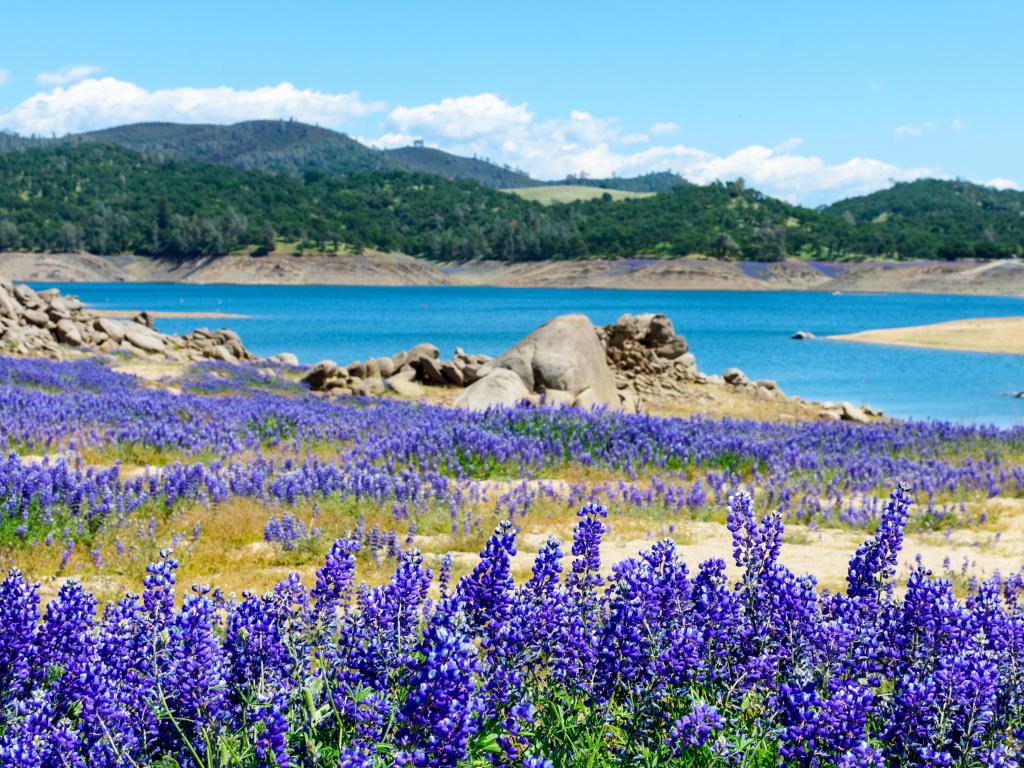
left=828, top=317, right=1024, bottom=354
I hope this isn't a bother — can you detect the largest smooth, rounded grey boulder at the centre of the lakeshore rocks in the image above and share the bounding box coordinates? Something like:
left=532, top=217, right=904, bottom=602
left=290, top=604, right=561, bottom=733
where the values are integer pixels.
left=487, top=314, right=618, bottom=408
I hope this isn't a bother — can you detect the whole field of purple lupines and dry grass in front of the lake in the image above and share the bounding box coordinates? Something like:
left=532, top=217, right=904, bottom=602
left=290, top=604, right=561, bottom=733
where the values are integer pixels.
left=0, top=357, right=1024, bottom=768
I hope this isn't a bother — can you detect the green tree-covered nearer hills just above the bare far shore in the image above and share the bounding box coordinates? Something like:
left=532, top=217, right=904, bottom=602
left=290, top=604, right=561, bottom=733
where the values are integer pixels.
left=0, top=142, right=1024, bottom=261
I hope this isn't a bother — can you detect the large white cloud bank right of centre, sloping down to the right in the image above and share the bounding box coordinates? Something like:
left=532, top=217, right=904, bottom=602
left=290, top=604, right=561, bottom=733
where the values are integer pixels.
left=374, top=93, right=943, bottom=204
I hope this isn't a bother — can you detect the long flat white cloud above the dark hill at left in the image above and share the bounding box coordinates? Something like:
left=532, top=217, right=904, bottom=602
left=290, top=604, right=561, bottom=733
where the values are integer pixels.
left=0, top=78, right=384, bottom=135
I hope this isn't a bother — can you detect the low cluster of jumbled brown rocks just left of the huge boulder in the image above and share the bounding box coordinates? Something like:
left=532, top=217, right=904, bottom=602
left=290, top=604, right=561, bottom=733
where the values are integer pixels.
left=302, top=343, right=490, bottom=397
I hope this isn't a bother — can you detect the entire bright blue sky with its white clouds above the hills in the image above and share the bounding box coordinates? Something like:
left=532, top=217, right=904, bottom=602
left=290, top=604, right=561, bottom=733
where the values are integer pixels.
left=0, top=0, right=1024, bottom=204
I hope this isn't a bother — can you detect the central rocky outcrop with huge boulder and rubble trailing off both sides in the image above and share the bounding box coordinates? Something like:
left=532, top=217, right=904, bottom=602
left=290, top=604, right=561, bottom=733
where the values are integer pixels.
left=303, top=313, right=881, bottom=422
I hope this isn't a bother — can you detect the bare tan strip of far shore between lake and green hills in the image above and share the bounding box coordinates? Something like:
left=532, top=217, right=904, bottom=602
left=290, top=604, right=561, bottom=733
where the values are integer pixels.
left=0, top=252, right=1024, bottom=297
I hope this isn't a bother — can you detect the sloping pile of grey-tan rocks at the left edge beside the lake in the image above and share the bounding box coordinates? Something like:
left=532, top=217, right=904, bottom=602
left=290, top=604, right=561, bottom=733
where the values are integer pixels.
left=0, top=280, right=256, bottom=361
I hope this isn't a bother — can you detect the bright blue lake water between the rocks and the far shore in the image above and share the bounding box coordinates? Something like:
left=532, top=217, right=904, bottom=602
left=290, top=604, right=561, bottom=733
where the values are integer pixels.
left=28, top=283, right=1024, bottom=425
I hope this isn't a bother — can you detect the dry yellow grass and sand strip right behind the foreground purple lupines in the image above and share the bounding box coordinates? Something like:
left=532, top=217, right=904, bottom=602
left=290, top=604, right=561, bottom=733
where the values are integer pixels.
left=6, top=475, right=1024, bottom=602
